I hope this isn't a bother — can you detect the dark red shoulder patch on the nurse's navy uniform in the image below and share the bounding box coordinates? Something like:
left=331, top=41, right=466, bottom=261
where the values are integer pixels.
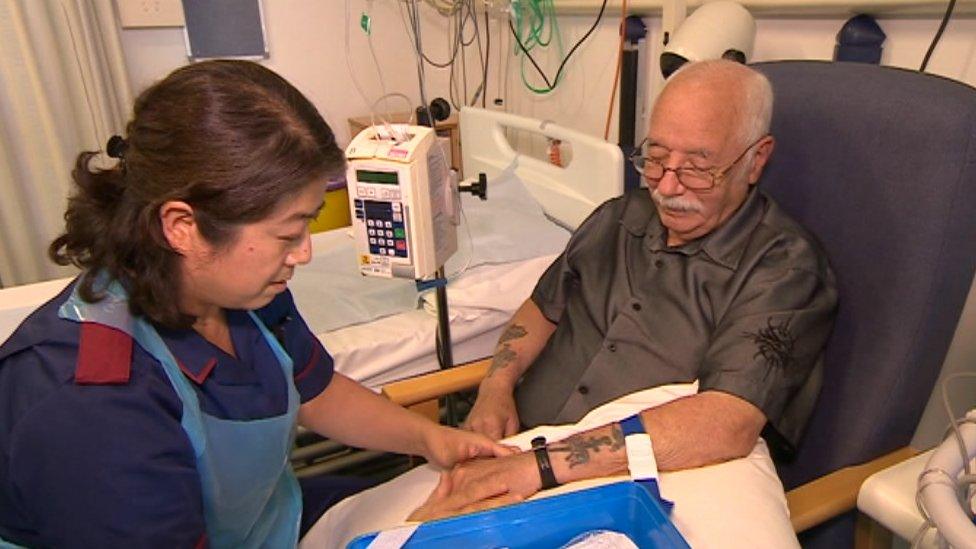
left=75, top=322, right=132, bottom=385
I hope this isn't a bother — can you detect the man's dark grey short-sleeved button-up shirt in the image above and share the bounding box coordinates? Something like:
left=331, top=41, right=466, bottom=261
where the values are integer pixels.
left=516, top=188, right=837, bottom=444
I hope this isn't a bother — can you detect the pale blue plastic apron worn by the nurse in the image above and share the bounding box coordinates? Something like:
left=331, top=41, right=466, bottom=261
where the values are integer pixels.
left=0, top=282, right=302, bottom=548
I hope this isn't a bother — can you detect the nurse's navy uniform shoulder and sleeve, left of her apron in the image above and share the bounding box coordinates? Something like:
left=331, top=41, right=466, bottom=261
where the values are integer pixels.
left=0, top=282, right=203, bottom=547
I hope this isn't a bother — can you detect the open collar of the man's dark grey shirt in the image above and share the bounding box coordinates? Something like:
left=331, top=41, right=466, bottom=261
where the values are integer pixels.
left=620, top=187, right=766, bottom=270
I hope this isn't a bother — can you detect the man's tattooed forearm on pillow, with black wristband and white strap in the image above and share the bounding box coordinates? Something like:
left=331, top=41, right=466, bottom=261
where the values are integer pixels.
left=549, top=391, right=765, bottom=483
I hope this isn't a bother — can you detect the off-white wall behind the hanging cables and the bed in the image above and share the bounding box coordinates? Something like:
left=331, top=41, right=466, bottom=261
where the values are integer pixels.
left=122, top=0, right=976, bottom=148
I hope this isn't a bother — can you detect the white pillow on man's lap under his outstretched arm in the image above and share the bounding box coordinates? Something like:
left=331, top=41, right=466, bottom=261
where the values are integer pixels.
left=299, top=383, right=799, bottom=549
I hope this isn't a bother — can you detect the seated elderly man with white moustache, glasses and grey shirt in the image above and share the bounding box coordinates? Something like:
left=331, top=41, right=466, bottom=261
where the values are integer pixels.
left=467, top=57, right=837, bottom=493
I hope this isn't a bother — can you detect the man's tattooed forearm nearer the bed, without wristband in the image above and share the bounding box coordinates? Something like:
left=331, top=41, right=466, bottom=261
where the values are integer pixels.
left=485, top=299, right=556, bottom=388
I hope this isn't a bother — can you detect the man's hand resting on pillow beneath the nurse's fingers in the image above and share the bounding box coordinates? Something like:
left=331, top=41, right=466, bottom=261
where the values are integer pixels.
left=407, top=471, right=522, bottom=521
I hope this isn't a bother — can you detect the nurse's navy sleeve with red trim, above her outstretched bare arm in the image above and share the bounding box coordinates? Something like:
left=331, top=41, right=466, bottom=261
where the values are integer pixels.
left=255, top=290, right=334, bottom=403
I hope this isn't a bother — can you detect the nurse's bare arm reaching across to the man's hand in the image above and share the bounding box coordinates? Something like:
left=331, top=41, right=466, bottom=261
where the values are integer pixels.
left=298, top=372, right=512, bottom=467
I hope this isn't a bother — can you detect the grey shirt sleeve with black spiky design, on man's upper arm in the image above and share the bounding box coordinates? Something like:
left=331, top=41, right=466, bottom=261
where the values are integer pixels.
left=700, top=253, right=837, bottom=438
